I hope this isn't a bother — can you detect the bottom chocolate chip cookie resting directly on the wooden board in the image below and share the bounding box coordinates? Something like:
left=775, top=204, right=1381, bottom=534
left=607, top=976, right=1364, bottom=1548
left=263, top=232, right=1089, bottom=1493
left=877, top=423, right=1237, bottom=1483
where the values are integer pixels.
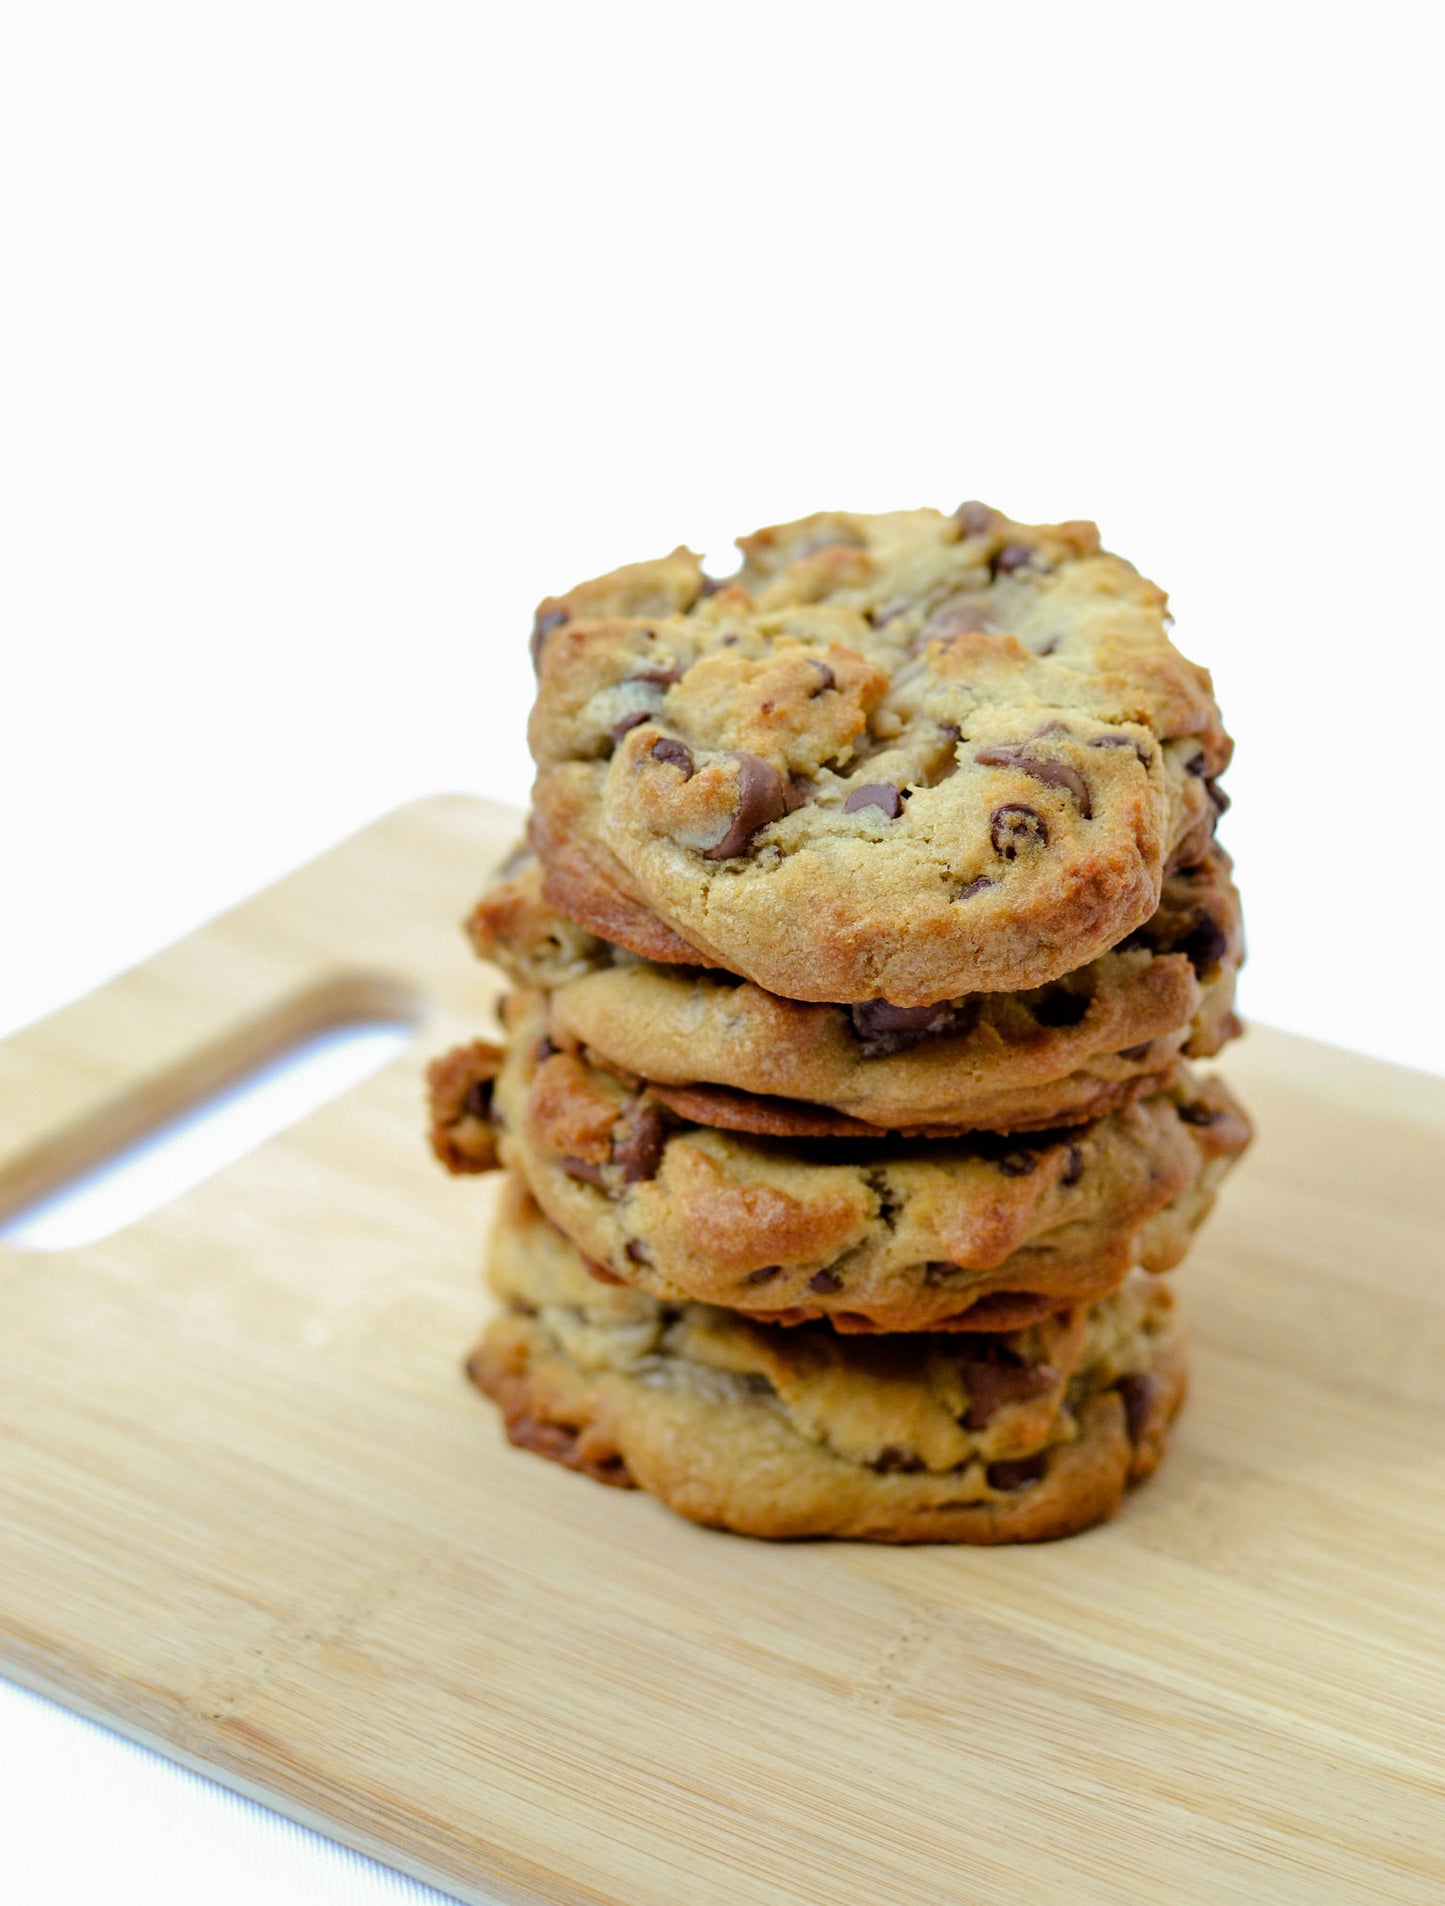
left=469, top=1184, right=1186, bottom=1544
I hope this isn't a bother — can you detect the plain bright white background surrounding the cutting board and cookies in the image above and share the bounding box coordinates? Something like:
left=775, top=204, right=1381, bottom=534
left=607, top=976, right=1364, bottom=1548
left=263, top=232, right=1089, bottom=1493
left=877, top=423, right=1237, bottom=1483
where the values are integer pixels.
left=0, top=0, right=1445, bottom=1906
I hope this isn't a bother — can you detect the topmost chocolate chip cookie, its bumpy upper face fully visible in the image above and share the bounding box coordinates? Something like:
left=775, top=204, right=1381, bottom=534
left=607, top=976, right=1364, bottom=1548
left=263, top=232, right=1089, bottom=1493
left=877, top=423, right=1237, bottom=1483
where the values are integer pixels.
left=530, top=503, right=1230, bottom=1006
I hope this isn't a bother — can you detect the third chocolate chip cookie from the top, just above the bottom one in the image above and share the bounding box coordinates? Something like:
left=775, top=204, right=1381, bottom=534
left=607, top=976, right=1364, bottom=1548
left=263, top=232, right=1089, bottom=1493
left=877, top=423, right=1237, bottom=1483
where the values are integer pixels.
left=478, top=993, right=1249, bottom=1330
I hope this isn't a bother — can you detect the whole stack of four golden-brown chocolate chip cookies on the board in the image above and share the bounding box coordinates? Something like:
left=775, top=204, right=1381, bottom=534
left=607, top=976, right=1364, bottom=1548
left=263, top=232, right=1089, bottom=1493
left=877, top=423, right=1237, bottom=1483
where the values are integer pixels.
left=431, top=503, right=1249, bottom=1542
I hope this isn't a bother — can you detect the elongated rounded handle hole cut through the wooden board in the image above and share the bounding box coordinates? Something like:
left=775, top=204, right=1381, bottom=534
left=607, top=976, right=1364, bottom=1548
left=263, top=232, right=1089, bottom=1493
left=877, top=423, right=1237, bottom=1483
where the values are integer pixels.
left=0, top=980, right=419, bottom=1250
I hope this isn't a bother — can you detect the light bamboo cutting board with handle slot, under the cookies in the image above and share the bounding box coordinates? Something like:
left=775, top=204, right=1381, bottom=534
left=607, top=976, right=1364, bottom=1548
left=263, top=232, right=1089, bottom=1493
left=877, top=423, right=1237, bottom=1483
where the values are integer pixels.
left=0, top=799, right=1445, bottom=1906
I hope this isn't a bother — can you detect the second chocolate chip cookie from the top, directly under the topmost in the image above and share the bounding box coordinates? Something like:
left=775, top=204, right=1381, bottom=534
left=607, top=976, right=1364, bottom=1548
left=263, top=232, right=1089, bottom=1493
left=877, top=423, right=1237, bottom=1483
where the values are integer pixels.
left=469, top=846, right=1243, bottom=1138
